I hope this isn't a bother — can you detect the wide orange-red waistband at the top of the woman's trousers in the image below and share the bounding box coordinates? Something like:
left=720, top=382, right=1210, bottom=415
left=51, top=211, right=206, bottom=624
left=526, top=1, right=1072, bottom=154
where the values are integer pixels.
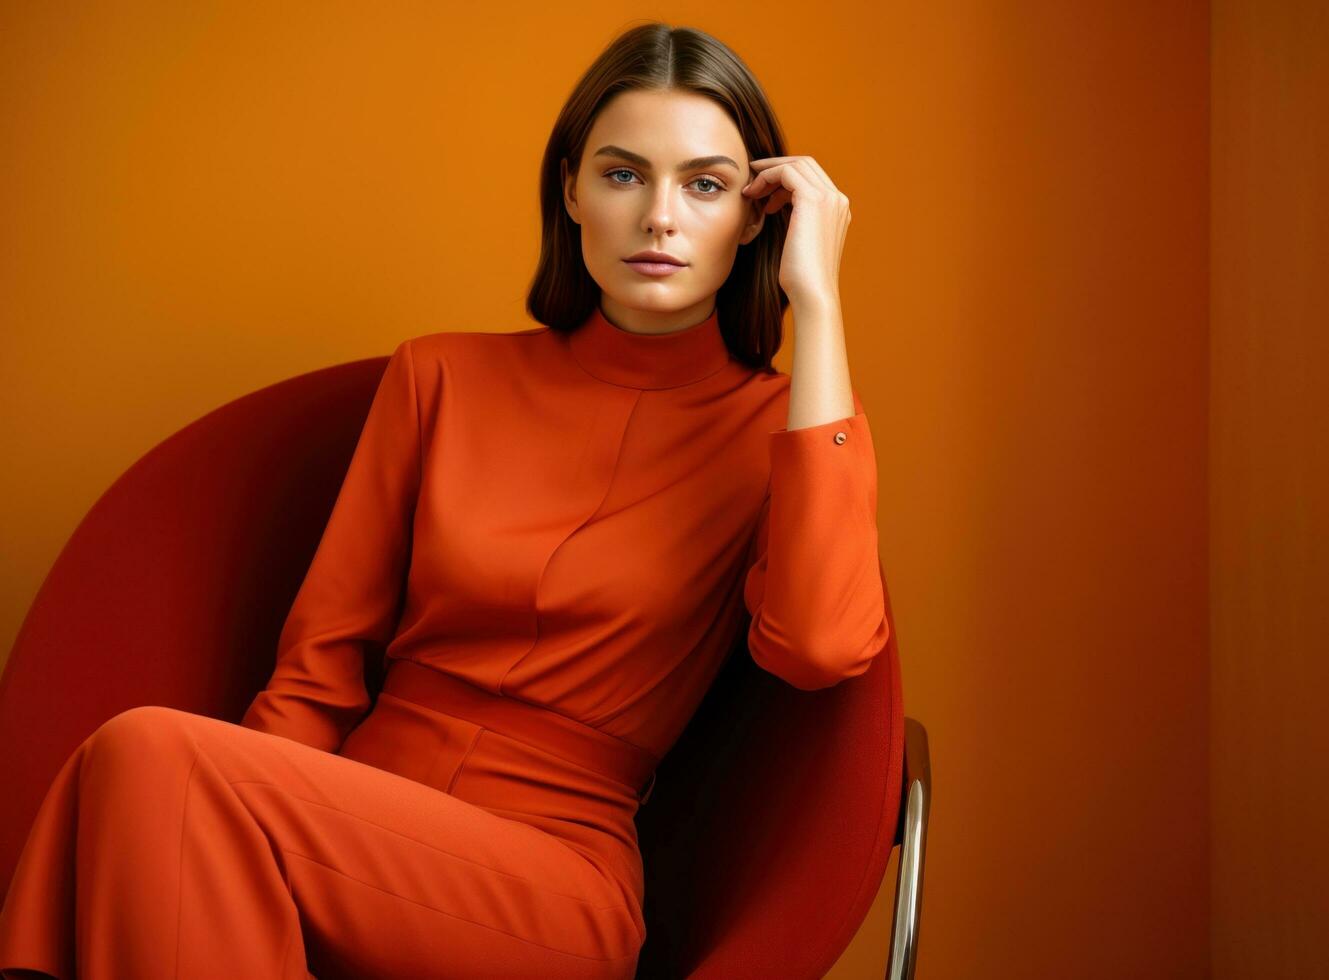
left=383, top=657, right=659, bottom=803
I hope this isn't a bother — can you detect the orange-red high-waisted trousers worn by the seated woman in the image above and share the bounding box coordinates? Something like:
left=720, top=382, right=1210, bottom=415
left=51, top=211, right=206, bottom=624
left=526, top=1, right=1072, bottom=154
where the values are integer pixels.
left=0, top=662, right=646, bottom=980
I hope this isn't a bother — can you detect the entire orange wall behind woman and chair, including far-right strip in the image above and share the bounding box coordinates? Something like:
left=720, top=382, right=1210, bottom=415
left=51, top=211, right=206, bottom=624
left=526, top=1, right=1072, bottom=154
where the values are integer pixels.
left=0, top=0, right=1329, bottom=979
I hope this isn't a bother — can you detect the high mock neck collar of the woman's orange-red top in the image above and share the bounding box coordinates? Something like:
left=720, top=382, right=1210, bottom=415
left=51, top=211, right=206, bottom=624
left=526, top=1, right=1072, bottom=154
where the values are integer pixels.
left=569, top=303, right=730, bottom=388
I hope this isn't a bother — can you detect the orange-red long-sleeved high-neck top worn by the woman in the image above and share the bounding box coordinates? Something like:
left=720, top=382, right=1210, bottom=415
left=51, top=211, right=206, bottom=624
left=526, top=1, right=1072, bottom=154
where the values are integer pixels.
left=242, top=301, right=890, bottom=758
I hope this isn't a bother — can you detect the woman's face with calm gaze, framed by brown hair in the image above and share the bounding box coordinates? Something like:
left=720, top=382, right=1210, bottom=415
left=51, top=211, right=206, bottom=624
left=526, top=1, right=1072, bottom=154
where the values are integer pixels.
left=562, top=90, right=764, bottom=334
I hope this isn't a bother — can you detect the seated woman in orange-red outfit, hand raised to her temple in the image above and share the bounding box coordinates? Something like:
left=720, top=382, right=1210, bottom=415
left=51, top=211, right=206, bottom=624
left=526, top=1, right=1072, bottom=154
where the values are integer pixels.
left=0, top=24, right=889, bottom=980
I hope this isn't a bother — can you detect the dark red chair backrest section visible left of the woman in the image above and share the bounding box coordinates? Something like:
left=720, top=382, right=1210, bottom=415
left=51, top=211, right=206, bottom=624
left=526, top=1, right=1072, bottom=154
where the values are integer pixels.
left=0, top=358, right=387, bottom=894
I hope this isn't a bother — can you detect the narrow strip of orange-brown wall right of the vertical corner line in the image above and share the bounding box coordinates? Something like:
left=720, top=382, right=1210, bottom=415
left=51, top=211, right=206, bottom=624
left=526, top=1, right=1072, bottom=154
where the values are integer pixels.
left=1209, top=0, right=1329, bottom=980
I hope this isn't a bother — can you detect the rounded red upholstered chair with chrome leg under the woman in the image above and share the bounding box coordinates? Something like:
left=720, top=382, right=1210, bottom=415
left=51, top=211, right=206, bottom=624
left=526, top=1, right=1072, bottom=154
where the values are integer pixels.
left=0, top=358, right=930, bottom=977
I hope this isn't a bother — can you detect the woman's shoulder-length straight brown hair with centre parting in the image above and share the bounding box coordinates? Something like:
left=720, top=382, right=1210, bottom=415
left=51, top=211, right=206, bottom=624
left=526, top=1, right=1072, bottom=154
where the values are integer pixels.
left=526, top=23, right=789, bottom=368
